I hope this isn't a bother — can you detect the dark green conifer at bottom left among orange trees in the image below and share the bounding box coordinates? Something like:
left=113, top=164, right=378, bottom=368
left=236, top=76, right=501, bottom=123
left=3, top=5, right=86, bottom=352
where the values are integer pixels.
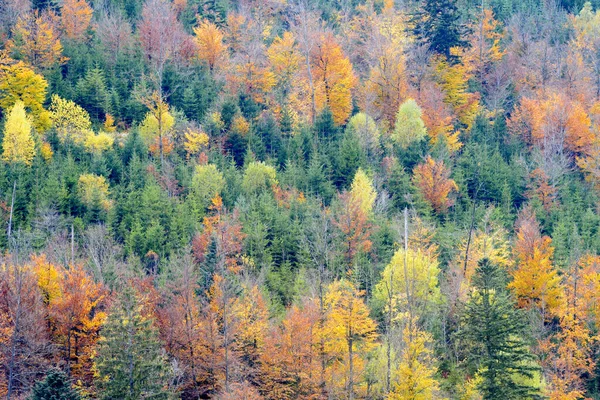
left=96, top=287, right=171, bottom=400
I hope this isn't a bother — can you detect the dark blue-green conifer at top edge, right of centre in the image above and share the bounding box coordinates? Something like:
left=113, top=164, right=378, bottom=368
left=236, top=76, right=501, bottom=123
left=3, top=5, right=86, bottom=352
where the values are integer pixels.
left=413, top=0, right=465, bottom=59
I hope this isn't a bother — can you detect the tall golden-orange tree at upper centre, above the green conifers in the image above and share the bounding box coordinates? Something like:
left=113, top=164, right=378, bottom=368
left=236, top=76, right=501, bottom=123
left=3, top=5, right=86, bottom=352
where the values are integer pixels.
left=310, top=33, right=356, bottom=125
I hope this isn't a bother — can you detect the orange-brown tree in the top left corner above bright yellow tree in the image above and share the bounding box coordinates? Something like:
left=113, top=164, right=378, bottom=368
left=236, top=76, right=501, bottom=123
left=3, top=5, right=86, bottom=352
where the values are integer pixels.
left=6, top=10, right=66, bottom=70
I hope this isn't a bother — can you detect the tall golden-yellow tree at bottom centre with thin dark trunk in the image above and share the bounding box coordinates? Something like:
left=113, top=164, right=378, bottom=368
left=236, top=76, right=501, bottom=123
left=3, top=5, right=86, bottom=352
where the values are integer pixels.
left=320, top=280, right=377, bottom=399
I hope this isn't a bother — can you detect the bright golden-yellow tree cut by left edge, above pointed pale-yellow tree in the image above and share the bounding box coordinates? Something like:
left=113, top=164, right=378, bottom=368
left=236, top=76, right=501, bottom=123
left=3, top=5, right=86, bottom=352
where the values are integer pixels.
left=0, top=60, right=51, bottom=132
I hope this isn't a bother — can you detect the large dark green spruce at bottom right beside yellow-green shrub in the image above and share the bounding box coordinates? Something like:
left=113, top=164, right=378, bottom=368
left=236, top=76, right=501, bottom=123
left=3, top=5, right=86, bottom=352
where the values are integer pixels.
left=463, top=259, right=539, bottom=400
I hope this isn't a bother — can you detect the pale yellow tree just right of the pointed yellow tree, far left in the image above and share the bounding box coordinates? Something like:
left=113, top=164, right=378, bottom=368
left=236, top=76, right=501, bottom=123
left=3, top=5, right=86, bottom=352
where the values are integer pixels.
left=50, top=95, right=93, bottom=144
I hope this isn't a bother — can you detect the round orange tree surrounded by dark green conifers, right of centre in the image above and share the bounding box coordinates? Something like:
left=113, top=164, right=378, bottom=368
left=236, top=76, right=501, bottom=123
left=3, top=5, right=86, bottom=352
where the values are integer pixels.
left=413, top=156, right=458, bottom=213
